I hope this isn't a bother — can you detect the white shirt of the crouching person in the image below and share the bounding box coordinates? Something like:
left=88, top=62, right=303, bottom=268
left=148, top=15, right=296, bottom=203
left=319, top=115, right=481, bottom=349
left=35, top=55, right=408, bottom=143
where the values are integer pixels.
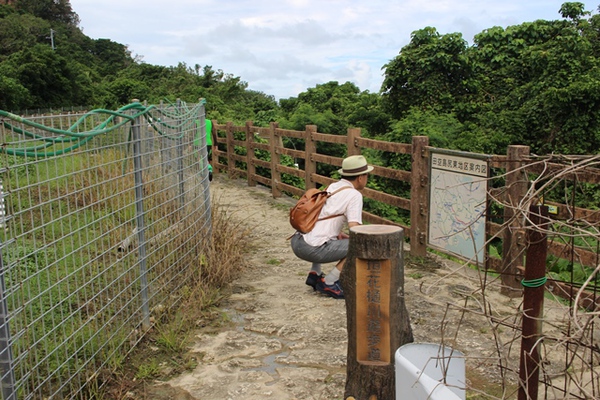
left=303, top=179, right=363, bottom=246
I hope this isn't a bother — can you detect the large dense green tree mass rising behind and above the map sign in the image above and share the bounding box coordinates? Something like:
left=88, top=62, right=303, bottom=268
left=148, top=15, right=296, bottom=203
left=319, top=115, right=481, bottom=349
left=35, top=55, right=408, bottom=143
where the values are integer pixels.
left=382, top=3, right=600, bottom=154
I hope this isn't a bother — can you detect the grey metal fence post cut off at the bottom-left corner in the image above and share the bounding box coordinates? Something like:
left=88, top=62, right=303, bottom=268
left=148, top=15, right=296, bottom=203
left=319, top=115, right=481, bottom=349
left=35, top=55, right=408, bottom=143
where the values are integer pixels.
left=0, top=248, right=17, bottom=400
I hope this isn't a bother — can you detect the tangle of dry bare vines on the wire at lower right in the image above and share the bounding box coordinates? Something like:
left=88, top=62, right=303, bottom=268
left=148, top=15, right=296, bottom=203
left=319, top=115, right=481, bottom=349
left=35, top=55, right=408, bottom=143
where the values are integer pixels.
left=421, top=155, right=600, bottom=399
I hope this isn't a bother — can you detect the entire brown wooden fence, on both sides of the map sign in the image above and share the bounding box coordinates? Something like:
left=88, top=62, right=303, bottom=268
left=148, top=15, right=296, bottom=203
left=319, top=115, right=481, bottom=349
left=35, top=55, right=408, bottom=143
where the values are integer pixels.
left=212, top=121, right=600, bottom=308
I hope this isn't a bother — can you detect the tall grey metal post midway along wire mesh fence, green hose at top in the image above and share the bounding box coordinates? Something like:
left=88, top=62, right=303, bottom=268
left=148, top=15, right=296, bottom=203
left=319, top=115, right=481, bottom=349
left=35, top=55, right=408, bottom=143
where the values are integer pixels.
left=131, top=104, right=150, bottom=329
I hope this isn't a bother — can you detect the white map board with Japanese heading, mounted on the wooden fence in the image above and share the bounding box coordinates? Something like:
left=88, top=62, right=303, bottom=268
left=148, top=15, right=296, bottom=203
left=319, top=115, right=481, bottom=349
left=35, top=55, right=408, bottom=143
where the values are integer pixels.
left=429, top=151, right=488, bottom=264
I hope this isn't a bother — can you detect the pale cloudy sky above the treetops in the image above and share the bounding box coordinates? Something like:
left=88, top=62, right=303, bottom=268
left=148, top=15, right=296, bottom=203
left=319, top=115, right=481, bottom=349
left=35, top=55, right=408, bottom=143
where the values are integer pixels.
left=70, top=0, right=597, bottom=99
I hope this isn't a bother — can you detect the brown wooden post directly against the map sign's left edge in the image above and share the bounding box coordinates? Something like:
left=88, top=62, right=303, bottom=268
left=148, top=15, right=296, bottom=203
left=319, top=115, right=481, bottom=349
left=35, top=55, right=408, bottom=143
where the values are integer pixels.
left=410, top=136, right=429, bottom=257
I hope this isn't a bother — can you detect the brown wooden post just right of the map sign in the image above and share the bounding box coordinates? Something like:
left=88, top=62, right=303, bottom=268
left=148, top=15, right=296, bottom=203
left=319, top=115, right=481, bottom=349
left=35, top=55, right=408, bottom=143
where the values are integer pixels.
left=500, top=145, right=529, bottom=297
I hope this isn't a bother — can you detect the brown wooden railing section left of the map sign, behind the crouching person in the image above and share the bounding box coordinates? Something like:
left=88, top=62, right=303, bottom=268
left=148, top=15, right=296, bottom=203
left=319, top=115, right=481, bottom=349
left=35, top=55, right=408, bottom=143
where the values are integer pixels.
left=213, top=121, right=429, bottom=256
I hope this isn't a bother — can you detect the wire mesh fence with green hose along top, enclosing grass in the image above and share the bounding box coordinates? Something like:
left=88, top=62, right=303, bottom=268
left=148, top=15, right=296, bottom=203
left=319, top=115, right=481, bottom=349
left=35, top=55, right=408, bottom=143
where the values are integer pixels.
left=0, top=102, right=211, bottom=400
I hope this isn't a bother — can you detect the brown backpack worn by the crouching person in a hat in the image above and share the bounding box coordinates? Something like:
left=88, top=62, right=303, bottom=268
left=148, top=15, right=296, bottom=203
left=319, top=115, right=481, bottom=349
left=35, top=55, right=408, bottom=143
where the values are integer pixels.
left=290, top=186, right=350, bottom=233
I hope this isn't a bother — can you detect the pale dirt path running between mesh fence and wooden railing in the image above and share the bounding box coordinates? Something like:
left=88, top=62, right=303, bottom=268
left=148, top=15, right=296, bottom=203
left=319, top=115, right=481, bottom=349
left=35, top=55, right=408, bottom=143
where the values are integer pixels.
left=149, top=176, right=516, bottom=400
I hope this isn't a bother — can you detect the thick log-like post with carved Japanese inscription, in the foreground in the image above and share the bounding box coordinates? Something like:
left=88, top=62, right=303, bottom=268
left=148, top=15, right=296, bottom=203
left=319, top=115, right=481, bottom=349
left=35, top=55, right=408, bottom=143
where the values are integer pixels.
left=341, top=225, right=413, bottom=400
